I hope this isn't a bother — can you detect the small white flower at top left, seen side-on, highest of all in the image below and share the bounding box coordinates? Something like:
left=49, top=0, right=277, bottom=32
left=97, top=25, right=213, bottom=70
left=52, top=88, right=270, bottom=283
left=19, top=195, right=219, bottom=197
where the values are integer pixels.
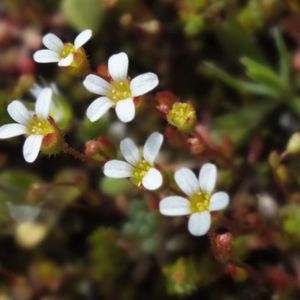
left=33, top=29, right=92, bottom=67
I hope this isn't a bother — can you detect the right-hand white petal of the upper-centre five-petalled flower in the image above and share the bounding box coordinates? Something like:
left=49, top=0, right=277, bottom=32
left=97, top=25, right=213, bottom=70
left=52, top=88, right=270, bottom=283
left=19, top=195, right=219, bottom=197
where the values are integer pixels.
left=130, top=73, right=158, bottom=97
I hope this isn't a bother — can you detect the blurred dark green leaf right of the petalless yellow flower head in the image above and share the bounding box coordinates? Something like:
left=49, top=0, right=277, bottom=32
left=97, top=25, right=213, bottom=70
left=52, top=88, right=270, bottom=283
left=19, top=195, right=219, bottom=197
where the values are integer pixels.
left=212, top=102, right=276, bottom=146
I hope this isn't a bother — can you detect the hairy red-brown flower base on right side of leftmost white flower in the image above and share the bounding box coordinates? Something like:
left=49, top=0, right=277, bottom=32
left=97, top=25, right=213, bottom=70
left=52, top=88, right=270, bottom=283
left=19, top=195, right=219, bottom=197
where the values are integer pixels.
left=41, top=117, right=64, bottom=155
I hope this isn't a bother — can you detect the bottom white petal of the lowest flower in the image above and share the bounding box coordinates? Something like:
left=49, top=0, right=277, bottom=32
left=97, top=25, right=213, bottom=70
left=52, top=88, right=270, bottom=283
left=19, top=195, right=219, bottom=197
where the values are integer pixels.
left=188, top=211, right=211, bottom=236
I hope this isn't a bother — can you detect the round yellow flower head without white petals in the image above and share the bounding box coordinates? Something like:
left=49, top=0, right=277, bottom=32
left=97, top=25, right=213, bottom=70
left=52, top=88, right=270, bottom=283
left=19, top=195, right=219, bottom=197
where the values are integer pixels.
left=167, top=102, right=197, bottom=133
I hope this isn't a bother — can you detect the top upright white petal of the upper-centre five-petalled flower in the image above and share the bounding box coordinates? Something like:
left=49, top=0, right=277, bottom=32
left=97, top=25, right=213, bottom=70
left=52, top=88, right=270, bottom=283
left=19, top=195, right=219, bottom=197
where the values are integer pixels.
left=108, top=52, right=128, bottom=80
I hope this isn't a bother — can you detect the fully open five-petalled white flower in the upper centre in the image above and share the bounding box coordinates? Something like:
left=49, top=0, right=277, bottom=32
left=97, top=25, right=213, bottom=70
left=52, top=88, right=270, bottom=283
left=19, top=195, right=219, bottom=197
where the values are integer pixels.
left=83, top=52, right=158, bottom=123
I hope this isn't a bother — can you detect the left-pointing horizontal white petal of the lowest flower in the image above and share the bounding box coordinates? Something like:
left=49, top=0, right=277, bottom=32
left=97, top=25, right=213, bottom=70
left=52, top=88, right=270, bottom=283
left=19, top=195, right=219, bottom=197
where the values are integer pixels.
left=159, top=196, right=190, bottom=216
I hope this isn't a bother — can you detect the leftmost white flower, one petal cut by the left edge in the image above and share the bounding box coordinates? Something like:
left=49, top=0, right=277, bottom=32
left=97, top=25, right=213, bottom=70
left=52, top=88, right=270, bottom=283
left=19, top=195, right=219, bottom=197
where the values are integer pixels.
left=0, top=88, right=53, bottom=163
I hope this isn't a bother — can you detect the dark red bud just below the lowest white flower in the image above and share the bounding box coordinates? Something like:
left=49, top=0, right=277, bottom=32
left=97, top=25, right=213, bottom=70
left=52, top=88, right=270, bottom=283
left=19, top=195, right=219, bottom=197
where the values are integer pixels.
left=211, top=232, right=233, bottom=262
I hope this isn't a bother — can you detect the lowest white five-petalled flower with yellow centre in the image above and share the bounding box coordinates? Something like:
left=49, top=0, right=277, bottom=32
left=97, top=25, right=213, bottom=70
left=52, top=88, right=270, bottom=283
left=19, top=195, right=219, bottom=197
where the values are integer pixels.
left=159, top=163, right=229, bottom=236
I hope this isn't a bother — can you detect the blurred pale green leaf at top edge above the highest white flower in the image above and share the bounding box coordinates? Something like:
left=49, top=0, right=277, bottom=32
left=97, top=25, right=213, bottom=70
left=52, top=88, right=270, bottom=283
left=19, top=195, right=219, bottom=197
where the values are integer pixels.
left=61, top=0, right=104, bottom=33
